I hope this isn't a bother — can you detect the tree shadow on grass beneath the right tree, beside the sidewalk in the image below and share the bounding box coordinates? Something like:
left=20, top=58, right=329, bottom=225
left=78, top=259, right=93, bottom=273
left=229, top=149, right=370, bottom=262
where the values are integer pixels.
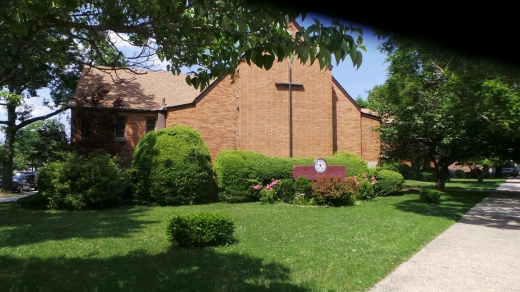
left=395, top=190, right=489, bottom=221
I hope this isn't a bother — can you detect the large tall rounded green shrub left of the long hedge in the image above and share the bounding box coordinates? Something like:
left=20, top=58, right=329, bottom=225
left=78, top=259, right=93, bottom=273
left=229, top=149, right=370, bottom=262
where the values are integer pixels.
left=131, top=126, right=212, bottom=205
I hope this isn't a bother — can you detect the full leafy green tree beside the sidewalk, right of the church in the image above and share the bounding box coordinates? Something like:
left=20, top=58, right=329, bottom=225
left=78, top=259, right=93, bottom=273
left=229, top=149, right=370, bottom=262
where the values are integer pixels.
left=368, top=35, right=520, bottom=190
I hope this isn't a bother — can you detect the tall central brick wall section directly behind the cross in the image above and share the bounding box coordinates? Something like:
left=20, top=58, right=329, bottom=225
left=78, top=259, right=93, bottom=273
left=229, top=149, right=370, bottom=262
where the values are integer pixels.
left=239, top=61, right=333, bottom=157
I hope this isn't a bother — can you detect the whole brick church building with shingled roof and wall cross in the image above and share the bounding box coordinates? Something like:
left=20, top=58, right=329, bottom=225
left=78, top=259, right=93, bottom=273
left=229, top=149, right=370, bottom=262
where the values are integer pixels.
left=72, top=22, right=381, bottom=165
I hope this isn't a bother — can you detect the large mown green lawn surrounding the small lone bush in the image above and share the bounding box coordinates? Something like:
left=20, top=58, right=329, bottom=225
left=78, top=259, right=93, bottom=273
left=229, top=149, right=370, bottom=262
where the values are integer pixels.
left=0, top=191, right=487, bottom=291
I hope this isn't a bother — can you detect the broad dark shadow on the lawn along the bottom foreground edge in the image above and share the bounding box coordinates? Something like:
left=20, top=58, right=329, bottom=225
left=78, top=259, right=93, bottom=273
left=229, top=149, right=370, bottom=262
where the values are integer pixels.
left=0, top=248, right=310, bottom=291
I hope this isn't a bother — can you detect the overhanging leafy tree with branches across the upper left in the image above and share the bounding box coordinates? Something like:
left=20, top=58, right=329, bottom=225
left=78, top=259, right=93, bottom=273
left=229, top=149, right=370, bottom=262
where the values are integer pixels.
left=0, top=0, right=365, bottom=190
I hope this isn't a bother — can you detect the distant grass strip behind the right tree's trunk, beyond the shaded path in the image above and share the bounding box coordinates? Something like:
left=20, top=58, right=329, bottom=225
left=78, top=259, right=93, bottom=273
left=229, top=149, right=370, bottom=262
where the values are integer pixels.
left=404, top=178, right=506, bottom=191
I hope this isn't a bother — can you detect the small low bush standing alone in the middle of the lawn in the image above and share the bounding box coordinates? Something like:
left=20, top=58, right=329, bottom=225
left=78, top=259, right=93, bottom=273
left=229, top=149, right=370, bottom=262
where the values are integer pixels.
left=166, top=212, right=235, bottom=247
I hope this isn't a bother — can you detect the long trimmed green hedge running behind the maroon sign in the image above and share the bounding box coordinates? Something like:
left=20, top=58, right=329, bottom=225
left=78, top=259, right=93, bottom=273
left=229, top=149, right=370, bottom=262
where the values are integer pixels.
left=213, top=150, right=367, bottom=203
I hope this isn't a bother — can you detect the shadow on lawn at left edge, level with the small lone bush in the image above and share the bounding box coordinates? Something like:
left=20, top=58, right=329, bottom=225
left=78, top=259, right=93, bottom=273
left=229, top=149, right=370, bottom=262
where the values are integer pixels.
left=0, top=203, right=157, bottom=247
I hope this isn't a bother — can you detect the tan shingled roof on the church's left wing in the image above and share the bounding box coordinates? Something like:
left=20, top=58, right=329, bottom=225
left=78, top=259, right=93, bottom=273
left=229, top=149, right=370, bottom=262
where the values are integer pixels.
left=72, top=68, right=201, bottom=110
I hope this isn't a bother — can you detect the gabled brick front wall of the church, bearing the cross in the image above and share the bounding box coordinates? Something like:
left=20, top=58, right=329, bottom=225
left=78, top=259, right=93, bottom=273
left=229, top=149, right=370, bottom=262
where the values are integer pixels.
left=162, top=61, right=380, bottom=163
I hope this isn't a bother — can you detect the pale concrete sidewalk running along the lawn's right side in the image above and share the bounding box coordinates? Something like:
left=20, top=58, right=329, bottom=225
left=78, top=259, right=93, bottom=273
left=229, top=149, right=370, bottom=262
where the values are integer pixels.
left=370, top=179, right=520, bottom=292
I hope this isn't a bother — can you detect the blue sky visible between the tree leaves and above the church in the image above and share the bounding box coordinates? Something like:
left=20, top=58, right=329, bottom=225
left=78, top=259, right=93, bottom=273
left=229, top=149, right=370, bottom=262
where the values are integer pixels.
left=0, top=14, right=387, bottom=139
